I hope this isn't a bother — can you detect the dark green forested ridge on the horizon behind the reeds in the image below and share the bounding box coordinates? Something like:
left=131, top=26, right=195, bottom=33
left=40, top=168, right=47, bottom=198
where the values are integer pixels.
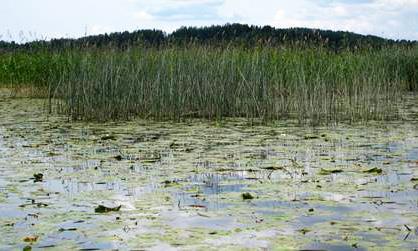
left=0, top=24, right=417, bottom=51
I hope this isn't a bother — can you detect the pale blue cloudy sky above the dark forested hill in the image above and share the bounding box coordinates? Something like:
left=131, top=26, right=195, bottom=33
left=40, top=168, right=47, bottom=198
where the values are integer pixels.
left=0, top=0, right=418, bottom=42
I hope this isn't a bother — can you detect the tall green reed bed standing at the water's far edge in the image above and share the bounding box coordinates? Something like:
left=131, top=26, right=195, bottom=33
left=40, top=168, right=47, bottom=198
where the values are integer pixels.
left=0, top=46, right=418, bottom=123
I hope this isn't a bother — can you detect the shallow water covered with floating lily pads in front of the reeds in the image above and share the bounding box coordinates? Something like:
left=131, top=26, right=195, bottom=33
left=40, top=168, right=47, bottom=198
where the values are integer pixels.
left=0, top=95, right=418, bottom=250
